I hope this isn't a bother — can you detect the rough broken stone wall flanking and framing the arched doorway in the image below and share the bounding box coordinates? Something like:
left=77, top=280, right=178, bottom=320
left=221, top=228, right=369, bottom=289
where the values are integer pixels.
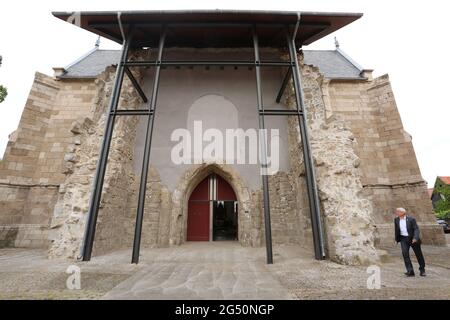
left=32, top=47, right=384, bottom=264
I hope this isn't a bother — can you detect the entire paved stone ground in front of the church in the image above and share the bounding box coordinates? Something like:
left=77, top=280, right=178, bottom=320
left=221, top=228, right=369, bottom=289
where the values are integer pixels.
left=0, top=242, right=450, bottom=299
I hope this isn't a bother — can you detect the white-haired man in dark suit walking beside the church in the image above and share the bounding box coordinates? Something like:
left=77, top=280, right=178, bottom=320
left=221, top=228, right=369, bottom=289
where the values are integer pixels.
left=394, top=208, right=426, bottom=277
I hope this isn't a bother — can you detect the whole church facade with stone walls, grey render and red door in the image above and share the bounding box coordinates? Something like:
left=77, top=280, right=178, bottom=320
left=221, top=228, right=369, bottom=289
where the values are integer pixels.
left=0, top=13, right=445, bottom=264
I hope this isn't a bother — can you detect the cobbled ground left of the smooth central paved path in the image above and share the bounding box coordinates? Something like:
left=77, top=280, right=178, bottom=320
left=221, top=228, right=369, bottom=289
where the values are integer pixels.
left=0, top=249, right=139, bottom=299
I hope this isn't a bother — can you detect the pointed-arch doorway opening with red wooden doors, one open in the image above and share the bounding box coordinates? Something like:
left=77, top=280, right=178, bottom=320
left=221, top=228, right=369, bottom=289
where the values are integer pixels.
left=186, top=173, right=238, bottom=241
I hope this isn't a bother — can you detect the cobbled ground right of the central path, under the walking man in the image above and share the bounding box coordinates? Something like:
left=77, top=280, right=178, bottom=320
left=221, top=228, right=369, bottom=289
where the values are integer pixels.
left=274, top=246, right=450, bottom=300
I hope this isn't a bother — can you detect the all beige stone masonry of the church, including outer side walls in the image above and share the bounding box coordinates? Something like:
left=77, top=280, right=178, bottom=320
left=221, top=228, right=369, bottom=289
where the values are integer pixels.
left=0, top=47, right=445, bottom=265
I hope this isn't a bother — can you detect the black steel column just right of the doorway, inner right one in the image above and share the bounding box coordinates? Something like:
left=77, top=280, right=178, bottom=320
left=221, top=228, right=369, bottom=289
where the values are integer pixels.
left=253, top=27, right=273, bottom=264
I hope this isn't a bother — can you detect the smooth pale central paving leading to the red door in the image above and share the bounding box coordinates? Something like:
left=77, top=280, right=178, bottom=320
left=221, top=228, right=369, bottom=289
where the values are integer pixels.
left=103, top=242, right=292, bottom=300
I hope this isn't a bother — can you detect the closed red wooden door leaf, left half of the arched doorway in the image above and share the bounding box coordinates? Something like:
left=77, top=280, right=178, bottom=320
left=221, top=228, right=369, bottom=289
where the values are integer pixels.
left=186, top=177, right=210, bottom=241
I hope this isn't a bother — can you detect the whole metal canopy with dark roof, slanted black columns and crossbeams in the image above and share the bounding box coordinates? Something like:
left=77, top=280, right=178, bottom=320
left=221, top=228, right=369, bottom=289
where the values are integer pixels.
left=53, top=10, right=362, bottom=264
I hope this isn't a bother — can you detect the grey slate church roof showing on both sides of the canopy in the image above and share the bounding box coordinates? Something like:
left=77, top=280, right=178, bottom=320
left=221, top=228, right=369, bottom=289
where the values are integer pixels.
left=60, top=49, right=364, bottom=79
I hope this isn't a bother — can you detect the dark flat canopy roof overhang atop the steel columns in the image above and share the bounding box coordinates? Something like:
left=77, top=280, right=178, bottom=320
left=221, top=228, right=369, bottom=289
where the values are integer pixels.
left=53, top=10, right=362, bottom=48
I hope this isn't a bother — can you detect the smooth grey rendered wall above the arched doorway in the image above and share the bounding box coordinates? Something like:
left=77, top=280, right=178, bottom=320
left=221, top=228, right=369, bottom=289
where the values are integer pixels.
left=134, top=49, right=289, bottom=191
